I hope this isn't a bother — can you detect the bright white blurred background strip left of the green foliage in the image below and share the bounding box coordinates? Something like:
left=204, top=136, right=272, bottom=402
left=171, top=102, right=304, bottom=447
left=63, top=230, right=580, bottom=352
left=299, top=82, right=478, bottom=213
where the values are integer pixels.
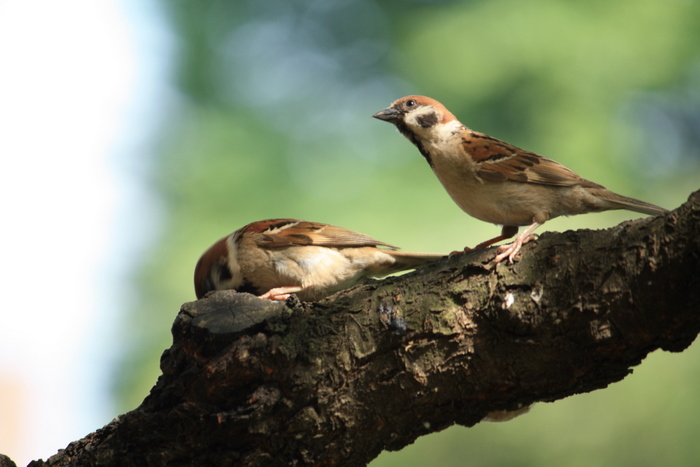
left=0, top=0, right=170, bottom=465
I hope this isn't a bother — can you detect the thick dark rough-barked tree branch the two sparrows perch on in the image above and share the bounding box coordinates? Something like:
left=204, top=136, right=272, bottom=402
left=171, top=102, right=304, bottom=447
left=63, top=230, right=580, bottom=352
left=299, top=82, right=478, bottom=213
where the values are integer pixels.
left=19, top=192, right=700, bottom=466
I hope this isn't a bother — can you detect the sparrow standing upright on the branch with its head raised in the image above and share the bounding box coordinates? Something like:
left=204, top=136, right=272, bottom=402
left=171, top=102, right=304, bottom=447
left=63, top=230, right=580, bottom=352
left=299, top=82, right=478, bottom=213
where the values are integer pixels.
left=373, top=96, right=668, bottom=263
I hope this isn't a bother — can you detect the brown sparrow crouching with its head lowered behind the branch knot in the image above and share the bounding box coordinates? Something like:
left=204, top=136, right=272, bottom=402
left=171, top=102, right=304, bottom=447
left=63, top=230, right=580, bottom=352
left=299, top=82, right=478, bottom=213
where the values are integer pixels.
left=194, top=219, right=445, bottom=301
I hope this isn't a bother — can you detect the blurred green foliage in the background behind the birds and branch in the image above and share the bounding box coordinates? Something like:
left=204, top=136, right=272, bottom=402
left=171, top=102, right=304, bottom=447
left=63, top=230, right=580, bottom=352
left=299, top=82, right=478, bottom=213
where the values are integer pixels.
left=115, top=0, right=700, bottom=467
